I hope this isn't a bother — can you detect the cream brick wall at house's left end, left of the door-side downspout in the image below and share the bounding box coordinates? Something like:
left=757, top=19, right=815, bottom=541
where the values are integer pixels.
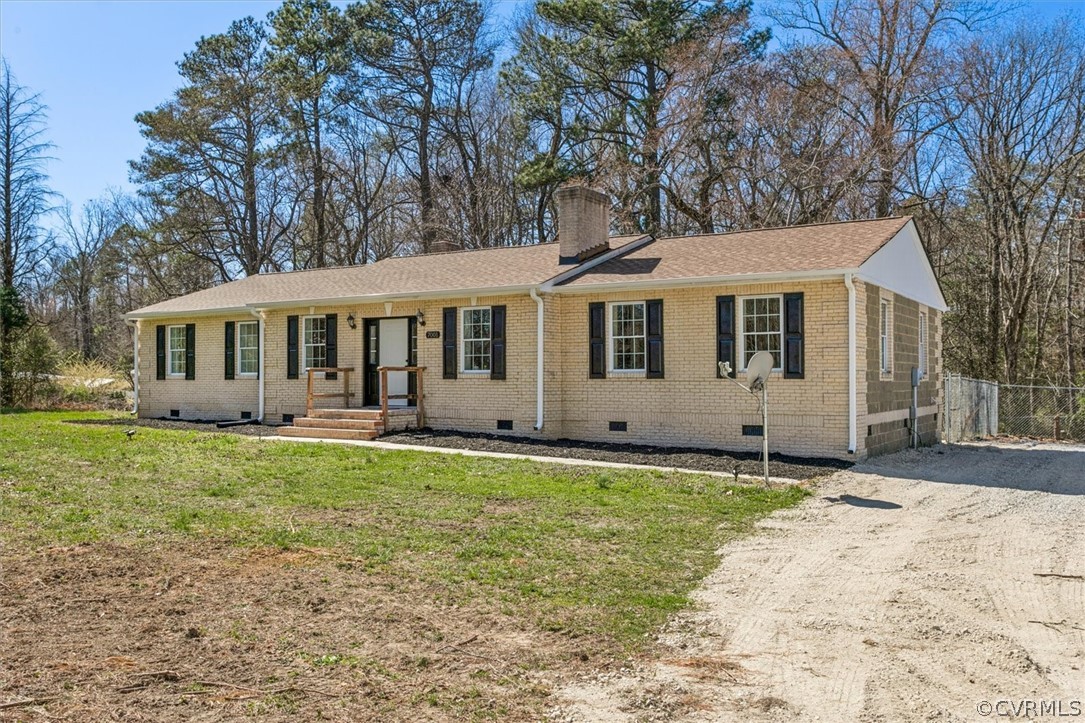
left=139, top=315, right=259, bottom=420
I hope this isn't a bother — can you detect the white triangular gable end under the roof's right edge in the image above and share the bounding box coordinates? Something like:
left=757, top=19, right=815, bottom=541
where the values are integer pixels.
left=859, top=221, right=948, bottom=312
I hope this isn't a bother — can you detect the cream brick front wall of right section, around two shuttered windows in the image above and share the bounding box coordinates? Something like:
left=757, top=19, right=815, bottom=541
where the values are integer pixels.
left=547, top=281, right=847, bottom=457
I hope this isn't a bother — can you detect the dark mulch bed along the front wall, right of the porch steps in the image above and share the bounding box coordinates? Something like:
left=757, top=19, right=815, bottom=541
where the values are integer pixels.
left=381, top=429, right=852, bottom=480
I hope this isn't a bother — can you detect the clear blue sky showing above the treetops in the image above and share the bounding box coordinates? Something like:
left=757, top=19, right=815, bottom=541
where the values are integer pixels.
left=0, top=0, right=1085, bottom=222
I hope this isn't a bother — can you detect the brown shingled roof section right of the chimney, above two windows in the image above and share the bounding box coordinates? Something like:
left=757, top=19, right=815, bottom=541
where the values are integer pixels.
left=561, top=216, right=910, bottom=288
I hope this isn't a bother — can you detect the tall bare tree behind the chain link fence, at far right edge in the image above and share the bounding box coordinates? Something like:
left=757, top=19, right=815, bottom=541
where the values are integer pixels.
left=946, top=21, right=1085, bottom=381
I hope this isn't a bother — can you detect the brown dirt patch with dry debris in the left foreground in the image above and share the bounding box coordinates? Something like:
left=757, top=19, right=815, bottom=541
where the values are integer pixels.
left=0, top=543, right=607, bottom=721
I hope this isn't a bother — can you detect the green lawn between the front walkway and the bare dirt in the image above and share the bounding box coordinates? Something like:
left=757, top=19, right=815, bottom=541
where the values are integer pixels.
left=0, top=413, right=804, bottom=649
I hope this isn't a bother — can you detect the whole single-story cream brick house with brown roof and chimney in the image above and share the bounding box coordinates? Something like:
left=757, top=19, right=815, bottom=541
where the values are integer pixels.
left=125, top=187, right=946, bottom=458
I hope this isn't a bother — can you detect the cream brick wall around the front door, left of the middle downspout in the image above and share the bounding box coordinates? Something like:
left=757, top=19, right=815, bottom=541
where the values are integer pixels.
left=139, top=294, right=542, bottom=434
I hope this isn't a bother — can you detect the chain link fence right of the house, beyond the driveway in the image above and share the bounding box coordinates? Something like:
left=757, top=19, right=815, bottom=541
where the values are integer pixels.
left=943, top=373, right=1085, bottom=443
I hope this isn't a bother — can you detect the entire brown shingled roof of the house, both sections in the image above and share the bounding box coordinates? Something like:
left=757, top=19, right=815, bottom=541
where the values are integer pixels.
left=129, top=217, right=909, bottom=317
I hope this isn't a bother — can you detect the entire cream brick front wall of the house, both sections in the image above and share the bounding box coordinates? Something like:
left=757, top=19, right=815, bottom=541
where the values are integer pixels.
left=133, top=273, right=941, bottom=458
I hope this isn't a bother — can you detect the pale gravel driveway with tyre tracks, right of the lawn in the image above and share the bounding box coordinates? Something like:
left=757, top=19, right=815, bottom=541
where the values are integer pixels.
left=551, top=444, right=1085, bottom=722
